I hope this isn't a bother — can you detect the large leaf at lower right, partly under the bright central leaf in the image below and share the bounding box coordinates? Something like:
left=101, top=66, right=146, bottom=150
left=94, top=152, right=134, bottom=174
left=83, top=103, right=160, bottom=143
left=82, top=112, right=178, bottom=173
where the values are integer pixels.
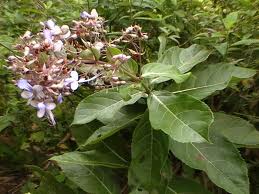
left=170, top=135, right=249, bottom=194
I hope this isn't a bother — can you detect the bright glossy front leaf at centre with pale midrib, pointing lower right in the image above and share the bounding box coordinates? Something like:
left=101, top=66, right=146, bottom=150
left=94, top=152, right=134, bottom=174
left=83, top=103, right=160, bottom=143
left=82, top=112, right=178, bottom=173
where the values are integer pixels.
left=148, top=92, right=213, bottom=142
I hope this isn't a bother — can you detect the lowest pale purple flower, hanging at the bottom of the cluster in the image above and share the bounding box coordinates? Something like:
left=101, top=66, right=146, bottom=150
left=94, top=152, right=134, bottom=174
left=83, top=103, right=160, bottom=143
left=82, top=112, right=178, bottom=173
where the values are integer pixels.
left=37, top=102, right=56, bottom=125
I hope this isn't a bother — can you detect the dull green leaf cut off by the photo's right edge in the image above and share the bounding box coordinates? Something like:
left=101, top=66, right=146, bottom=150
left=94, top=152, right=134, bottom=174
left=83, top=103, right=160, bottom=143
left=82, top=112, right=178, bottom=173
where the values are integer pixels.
left=210, top=113, right=259, bottom=146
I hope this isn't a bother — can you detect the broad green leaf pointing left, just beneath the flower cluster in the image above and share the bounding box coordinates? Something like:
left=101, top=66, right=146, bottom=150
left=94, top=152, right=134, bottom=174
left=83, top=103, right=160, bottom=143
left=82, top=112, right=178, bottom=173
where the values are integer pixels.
left=73, top=89, right=143, bottom=124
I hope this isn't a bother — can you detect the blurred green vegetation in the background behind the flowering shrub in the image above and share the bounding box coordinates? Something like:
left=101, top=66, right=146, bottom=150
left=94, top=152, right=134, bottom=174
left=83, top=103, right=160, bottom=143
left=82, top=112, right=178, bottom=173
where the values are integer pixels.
left=0, top=0, right=259, bottom=194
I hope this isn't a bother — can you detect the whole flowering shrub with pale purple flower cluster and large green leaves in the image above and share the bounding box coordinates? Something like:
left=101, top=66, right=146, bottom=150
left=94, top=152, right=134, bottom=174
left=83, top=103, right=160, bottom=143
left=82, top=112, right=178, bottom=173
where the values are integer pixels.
left=3, top=1, right=259, bottom=194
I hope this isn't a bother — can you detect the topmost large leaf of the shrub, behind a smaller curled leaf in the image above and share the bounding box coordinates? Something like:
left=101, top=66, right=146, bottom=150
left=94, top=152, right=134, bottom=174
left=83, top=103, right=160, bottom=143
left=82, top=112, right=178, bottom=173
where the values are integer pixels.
left=158, top=44, right=210, bottom=73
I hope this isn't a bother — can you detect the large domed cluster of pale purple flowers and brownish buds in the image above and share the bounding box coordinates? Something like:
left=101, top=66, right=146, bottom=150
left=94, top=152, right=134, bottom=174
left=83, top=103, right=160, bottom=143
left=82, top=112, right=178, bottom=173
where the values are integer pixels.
left=7, top=9, right=147, bottom=125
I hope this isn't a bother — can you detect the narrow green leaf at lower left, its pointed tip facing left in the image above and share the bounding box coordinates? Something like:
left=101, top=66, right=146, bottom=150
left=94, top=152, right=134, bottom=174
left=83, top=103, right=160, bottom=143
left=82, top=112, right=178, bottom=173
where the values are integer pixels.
left=50, top=149, right=127, bottom=168
